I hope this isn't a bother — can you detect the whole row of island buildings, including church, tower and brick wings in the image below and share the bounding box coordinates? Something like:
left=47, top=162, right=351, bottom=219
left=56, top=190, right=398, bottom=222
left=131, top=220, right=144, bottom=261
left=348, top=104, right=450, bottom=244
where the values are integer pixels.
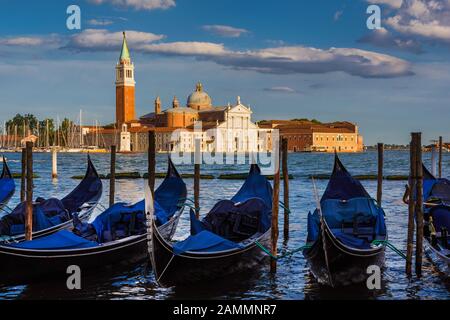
left=85, top=33, right=363, bottom=152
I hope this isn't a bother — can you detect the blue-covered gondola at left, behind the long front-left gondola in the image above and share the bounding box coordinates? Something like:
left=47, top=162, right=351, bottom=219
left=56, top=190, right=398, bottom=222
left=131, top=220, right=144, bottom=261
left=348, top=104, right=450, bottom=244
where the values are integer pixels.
left=0, top=156, right=103, bottom=243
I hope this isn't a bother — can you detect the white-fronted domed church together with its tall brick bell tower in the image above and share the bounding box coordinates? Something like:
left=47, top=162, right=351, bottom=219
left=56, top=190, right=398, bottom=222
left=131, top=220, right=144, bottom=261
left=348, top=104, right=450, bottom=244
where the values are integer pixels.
left=109, top=32, right=273, bottom=152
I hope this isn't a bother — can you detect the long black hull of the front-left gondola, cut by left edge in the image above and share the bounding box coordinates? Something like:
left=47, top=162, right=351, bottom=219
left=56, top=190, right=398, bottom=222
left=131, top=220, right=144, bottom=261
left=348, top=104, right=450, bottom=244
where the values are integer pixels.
left=0, top=210, right=183, bottom=285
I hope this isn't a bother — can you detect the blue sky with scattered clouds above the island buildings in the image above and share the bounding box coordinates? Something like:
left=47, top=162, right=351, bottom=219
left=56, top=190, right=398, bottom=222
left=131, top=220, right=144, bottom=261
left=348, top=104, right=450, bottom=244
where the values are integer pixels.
left=0, top=0, right=450, bottom=145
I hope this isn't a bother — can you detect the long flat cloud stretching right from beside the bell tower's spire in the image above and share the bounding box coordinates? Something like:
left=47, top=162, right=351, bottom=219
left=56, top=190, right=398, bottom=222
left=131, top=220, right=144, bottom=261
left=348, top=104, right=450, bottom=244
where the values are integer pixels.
left=137, top=42, right=412, bottom=78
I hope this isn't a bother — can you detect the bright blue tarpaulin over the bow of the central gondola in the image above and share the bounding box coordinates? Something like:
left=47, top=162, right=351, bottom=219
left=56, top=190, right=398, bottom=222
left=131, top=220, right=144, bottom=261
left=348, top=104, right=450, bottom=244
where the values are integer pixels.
left=173, top=230, right=241, bottom=254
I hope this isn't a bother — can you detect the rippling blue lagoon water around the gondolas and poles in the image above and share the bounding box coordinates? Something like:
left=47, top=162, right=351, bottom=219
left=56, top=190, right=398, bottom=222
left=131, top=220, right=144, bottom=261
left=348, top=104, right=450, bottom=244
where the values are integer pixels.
left=0, top=151, right=450, bottom=300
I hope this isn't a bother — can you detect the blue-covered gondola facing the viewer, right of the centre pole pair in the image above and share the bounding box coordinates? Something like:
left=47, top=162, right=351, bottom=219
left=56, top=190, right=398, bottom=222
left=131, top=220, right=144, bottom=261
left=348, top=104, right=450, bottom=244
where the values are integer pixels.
left=303, top=154, right=387, bottom=287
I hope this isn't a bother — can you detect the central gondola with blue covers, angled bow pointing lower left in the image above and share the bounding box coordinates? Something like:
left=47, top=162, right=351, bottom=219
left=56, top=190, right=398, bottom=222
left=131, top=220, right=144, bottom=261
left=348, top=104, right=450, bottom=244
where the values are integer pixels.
left=147, top=164, right=272, bottom=286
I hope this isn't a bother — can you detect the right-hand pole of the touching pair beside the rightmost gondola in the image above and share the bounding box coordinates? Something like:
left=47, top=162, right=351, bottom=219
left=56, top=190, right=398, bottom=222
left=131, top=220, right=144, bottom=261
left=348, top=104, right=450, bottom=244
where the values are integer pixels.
left=415, top=133, right=424, bottom=277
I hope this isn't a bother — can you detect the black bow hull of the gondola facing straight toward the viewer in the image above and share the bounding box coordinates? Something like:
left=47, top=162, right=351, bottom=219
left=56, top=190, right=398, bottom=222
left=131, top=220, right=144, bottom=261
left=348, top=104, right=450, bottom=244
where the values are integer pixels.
left=303, top=227, right=385, bottom=287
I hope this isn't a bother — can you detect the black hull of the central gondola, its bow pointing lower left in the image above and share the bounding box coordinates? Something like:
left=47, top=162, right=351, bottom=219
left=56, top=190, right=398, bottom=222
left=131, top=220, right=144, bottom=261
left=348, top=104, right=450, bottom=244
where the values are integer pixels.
left=151, top=222, right=270, bottom=287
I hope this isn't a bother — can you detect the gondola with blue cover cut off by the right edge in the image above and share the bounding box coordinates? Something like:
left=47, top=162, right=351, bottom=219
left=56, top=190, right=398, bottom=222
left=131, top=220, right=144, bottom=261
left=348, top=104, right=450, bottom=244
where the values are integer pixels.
left=423, top=166, right=450, bottom=275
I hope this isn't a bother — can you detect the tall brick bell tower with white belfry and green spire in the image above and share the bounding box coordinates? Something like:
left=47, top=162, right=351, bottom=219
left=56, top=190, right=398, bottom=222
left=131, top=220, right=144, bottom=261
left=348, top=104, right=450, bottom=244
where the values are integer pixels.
left=116, top=32, right=136, bottom=128
